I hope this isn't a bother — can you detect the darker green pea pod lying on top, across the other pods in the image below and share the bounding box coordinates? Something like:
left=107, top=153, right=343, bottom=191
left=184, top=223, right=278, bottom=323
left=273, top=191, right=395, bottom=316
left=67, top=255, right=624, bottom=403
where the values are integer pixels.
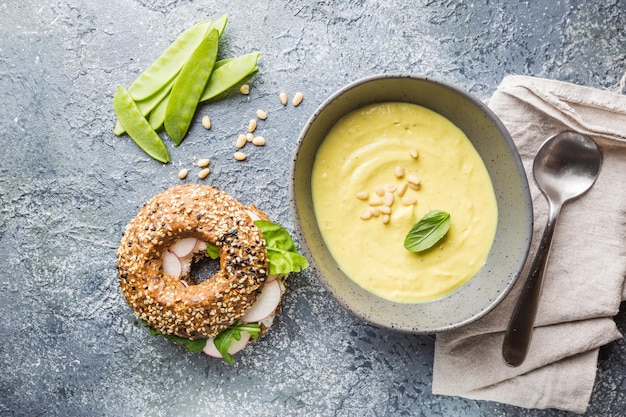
left=163, top=29, right=219, bottom=146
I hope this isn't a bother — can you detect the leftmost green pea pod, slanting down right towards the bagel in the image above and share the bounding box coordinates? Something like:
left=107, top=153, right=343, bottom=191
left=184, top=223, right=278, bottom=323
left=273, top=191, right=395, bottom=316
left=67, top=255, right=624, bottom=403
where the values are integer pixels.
left=113, top=85, right=170, bottom=164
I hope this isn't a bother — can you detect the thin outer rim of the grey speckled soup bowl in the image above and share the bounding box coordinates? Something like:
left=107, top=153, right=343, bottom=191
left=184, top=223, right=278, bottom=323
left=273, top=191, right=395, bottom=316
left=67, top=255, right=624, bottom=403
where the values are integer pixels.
left=288, top=72, right=534, bottom=334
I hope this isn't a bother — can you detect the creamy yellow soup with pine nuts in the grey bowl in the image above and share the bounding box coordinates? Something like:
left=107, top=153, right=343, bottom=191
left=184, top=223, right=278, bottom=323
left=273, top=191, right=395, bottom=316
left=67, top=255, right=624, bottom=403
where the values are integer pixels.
left=312, top=102, right=498, bottom=303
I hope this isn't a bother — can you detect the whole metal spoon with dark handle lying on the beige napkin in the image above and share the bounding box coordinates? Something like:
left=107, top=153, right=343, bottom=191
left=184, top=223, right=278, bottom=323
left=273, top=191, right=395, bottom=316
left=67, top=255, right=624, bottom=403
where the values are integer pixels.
left=502, top=132, right=602, bottom=366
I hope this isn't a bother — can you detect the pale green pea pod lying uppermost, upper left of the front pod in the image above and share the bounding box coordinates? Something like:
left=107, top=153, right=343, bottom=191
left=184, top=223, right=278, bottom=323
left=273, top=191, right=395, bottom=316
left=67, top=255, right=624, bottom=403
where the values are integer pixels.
left=128, top=20, right=211, bottom=101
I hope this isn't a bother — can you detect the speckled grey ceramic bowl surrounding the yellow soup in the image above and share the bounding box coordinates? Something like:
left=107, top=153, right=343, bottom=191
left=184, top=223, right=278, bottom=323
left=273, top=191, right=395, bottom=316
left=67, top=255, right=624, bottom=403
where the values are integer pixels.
left=290, top=74, right=533, bottom=333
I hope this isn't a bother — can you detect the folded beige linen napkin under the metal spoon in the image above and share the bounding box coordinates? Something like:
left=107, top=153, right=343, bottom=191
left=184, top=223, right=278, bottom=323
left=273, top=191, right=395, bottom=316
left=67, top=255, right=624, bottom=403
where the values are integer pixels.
left=432, top=76, right=626, bottom=413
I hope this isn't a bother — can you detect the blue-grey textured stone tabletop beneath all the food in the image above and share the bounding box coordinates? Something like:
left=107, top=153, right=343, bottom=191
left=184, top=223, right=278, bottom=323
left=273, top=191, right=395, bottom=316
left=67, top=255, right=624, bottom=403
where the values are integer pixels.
left=0, top=0, right=626, bottom=416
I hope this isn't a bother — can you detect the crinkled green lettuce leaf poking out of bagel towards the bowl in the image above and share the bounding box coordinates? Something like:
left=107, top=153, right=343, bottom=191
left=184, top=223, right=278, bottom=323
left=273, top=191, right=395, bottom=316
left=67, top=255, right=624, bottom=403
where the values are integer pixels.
left=254, top=220, right=309, bottom=275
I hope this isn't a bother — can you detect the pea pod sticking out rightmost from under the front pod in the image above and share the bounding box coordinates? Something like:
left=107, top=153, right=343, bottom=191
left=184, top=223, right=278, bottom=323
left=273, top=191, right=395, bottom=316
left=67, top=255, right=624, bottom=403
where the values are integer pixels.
left=200, top=52, right=261, bottom=102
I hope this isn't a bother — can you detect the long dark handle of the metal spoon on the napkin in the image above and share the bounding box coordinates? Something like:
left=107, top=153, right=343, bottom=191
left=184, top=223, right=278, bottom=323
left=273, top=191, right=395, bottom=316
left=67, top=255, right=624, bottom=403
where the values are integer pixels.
left=502, top=203, right=561, bottom=366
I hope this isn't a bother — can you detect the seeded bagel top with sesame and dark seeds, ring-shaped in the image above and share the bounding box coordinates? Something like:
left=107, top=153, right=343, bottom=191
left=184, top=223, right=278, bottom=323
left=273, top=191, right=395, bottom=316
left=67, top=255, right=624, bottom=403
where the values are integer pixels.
left=117, top=184, right=268, bottom=339
